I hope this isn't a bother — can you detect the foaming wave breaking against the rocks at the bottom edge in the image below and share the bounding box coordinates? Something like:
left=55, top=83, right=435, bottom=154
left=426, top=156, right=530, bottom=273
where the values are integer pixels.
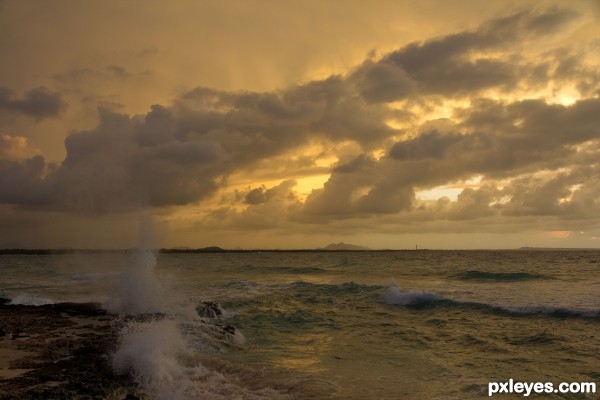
left=112, top=319, right=336, bottom=400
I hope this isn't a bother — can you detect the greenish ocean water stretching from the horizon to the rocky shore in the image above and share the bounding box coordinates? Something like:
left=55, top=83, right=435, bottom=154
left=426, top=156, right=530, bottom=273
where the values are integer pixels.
left=0, top=250, right=600, bottom=399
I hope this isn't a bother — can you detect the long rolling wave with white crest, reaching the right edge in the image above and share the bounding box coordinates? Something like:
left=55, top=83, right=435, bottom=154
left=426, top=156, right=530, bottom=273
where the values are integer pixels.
left=381, top=282, right=600, bottom=319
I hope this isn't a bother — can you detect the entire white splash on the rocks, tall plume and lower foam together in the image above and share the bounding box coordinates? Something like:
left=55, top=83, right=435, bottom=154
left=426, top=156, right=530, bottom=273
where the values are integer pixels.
left=108, top=216, right=293, bottom=400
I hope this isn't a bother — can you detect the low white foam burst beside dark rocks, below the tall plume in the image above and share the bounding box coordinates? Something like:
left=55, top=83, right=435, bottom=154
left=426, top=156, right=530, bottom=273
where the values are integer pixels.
left=112, top=319, right=288, bottom=400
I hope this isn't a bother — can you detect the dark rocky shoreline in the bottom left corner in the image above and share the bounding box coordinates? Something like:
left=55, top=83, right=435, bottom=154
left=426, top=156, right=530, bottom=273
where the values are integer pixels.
left=0, top=299, right=144, bottom=400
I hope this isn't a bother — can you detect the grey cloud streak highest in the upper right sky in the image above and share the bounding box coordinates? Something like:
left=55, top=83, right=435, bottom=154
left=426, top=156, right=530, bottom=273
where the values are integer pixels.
left=353, top=10, right=577, bottom=102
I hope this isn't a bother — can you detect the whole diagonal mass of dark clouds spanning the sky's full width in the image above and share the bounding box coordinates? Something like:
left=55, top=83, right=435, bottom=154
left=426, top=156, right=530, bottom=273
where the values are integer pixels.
left=0, top=5, right=600, bottom=227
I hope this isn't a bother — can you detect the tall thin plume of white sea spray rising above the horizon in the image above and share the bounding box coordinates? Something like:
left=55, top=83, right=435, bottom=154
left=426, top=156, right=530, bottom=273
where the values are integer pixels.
left=107, top=214, right=166, bottom=314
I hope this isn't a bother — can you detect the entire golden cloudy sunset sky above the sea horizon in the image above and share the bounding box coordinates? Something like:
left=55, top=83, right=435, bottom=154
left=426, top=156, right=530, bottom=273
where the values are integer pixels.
left=0, top=0, right=600, bottom=249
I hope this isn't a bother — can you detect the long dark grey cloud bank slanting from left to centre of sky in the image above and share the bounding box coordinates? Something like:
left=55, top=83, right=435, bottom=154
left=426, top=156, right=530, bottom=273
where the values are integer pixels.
left=0, top=77, right=396, bottom=212
